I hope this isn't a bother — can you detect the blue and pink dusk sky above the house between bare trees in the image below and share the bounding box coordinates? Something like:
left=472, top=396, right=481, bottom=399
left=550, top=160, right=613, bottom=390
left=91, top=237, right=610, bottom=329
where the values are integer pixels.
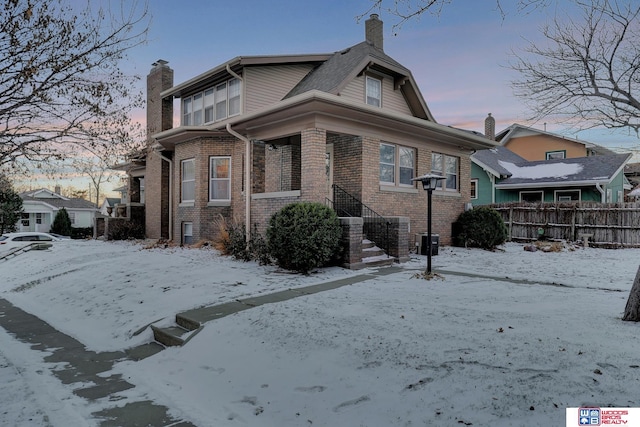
left=37, top=0, right=640, bottom=197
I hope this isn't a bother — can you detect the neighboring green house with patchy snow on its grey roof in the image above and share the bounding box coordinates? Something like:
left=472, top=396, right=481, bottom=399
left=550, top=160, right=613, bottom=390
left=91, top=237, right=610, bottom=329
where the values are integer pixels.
left=471, top=146, right=631, bottom=206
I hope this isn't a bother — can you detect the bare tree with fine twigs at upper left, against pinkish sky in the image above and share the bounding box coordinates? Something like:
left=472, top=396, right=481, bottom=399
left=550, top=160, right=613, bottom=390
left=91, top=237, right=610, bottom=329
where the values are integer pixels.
left=0, top=0, right=148, bottom=168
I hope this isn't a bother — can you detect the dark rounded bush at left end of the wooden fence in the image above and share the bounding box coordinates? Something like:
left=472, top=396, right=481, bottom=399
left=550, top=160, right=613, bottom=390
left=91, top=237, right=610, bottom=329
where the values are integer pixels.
left=454, top=206, right=507, bottom=250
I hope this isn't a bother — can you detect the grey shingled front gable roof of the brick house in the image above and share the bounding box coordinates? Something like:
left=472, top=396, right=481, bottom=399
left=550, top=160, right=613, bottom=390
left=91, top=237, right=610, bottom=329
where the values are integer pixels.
left=284, top=41, right=435, bottom=121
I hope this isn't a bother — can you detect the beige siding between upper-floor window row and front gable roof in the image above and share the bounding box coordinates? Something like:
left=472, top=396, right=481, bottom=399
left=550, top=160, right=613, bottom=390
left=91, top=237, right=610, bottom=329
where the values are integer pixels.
left=243, top=64, right=313, bottom=113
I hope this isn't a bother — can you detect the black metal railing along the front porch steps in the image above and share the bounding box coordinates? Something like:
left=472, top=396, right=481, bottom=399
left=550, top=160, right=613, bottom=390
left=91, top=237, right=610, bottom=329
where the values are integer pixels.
left=331, top=184, right=391, bottom=256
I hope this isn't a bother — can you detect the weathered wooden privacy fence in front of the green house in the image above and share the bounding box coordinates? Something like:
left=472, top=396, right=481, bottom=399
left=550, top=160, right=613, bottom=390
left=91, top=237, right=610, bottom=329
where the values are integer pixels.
left=491, top=202, right=640, bottom=248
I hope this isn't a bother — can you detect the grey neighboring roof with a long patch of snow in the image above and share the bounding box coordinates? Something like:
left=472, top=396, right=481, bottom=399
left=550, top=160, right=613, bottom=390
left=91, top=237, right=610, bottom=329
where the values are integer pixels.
left=496, top=154, right=631, bottom=188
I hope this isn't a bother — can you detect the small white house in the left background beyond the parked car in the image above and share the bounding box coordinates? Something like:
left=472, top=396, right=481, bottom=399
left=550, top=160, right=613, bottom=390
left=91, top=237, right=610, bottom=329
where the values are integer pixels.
left=18, top=187, right=98, bottom=232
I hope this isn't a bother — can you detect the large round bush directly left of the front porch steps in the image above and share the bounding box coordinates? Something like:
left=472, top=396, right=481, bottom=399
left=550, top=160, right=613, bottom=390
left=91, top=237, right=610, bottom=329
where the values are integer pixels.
left=267, top=202, right=342, bottom=274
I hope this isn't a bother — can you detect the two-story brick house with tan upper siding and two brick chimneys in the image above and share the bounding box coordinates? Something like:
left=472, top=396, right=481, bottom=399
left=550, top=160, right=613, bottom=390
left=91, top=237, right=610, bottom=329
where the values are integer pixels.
left=130, top=15, right=497, bottom=264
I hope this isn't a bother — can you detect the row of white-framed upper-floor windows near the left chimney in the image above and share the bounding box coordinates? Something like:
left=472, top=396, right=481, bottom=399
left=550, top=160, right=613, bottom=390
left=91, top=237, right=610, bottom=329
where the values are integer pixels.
left=182, top=78, right=241, bottom=126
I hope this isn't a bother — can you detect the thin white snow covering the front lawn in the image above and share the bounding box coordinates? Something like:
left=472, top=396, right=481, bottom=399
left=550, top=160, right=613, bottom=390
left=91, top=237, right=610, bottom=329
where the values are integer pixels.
left=0, top=241, right=640, bottom=427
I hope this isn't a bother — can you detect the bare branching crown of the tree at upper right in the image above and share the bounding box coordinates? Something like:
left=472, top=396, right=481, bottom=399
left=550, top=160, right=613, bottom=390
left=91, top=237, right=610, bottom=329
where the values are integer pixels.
left=511, top=0, right=640, bottom=133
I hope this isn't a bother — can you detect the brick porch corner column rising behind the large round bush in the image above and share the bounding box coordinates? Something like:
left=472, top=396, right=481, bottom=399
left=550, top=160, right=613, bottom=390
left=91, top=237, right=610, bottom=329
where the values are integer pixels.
left=300, top=129, right=327, bottom=203
